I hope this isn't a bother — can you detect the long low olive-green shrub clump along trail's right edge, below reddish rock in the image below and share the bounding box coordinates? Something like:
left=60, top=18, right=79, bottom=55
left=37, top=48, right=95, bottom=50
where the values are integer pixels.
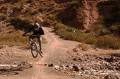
left=55, top=23, right=96, bottom=44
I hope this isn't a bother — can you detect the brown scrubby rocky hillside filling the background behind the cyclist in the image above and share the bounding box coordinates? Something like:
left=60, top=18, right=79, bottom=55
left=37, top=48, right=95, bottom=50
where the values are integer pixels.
left=0, top=0, right=120, bottom=47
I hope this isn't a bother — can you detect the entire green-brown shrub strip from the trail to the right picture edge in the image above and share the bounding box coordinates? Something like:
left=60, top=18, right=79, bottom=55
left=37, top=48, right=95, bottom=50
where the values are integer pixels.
left=55, top=23, right=120, bottom=49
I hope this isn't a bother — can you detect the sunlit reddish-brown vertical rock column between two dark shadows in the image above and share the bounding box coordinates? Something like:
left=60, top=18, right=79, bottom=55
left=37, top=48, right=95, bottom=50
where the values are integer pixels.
left=77, top=0, right=99, bottom=30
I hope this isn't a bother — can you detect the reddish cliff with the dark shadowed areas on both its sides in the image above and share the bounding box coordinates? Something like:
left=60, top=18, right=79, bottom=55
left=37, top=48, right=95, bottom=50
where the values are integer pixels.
left=57, top=0, right=120, bottom=31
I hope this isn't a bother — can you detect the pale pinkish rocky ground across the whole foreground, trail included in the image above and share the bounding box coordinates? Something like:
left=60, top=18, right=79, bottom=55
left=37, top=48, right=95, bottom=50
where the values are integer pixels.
left=0, top=28, right=120, bottom=79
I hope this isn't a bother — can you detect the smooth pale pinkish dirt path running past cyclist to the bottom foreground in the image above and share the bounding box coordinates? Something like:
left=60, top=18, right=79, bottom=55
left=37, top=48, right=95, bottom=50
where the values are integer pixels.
left=0, top=28, right=77, bottom=79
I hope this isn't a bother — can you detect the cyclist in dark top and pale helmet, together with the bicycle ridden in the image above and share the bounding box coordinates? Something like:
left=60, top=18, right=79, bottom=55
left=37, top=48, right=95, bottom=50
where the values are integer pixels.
left=23, top=17, right=44, bottom=58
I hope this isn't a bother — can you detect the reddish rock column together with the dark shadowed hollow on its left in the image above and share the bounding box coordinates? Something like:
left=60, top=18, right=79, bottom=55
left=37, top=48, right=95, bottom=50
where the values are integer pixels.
left=57, top=0, right=101, bottom=30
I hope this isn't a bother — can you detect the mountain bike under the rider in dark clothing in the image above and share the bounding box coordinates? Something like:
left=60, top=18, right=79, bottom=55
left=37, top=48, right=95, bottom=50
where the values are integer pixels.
left=25, top=35, right=43, bottom=58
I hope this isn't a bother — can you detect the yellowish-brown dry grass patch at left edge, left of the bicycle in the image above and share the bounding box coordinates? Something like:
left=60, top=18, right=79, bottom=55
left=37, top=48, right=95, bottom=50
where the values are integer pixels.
left=0, top=32, right=27, bottom=46
